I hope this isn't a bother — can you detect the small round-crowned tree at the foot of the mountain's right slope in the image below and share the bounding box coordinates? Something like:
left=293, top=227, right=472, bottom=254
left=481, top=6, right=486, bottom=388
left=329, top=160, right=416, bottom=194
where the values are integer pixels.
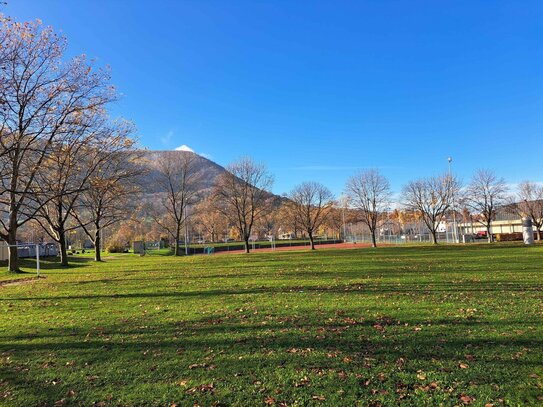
left=288, top=182, right=333, bottom=250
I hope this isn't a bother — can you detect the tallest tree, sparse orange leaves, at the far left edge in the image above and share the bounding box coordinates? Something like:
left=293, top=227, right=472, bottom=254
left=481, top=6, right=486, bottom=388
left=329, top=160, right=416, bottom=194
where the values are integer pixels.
left=0, top=19, right=114, bottom=272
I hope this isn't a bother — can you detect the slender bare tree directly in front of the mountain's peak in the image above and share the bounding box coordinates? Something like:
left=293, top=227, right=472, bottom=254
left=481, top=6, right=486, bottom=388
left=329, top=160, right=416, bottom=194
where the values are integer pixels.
left=150, top=151, right=200, bottom=256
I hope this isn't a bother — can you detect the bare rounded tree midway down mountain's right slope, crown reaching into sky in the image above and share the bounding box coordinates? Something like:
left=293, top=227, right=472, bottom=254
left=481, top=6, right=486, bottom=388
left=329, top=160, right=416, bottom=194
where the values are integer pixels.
left=214, top=157, right=273, bottom=253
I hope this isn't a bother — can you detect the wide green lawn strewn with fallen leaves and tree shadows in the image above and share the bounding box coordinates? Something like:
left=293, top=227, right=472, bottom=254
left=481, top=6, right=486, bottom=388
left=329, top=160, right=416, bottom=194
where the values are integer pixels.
left=0, top=244, right=543, bottom=406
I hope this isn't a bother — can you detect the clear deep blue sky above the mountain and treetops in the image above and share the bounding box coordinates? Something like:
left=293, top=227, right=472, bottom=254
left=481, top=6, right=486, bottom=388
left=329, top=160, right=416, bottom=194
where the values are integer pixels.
left=4, top=0, right=543, bottom=198
